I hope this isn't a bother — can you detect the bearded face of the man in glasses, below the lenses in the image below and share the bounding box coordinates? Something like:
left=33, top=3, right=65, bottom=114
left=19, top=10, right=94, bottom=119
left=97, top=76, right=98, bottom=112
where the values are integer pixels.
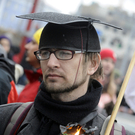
left=40, top=50, right=88, bottom=94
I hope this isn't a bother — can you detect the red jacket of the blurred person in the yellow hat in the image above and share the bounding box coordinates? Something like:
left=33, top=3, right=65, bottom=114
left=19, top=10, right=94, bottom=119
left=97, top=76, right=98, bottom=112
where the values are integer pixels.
left=17, top=68, right=42, bottom=102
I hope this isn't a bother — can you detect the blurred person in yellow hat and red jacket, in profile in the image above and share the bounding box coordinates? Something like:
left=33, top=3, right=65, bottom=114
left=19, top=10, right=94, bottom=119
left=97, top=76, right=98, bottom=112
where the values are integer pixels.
left=17, top=28, right=43, bottom=102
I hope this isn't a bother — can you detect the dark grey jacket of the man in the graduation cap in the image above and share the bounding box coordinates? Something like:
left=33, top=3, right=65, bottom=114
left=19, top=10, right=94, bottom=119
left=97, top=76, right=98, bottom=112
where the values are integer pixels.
left=0, top=103, right=105, bottom=135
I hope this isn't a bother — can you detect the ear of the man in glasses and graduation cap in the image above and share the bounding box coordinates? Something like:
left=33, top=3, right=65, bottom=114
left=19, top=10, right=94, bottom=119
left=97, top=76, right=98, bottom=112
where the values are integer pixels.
left=88, top=54, right=101, bottom=75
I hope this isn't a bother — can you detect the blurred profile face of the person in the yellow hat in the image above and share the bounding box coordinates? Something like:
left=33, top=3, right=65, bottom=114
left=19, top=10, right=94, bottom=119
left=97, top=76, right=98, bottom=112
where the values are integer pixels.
left=25, top=40, right=39, bottom=66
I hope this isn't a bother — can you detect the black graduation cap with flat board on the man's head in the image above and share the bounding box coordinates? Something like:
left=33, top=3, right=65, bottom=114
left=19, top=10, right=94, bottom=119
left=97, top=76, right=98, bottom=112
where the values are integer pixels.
left=17, top=12, right=121, bottom=52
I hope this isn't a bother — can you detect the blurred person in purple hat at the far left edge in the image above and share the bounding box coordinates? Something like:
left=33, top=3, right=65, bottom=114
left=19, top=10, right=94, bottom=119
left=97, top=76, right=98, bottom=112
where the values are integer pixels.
left=0, top=35, right=14, bottom=60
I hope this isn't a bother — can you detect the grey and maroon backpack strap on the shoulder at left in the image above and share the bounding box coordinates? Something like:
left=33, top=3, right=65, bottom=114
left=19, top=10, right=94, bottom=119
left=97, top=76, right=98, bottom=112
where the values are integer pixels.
left=4, top=102, right=33, bottom=135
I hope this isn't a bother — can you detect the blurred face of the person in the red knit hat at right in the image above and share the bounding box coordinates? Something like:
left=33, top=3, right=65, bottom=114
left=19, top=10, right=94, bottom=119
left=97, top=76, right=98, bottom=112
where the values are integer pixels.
left=101, top=58, right=115, bottom=75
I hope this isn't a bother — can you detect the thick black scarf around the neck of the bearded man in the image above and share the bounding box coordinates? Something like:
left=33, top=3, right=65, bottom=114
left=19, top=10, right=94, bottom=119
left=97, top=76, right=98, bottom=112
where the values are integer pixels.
left=34, top=80, right=102, bottom=125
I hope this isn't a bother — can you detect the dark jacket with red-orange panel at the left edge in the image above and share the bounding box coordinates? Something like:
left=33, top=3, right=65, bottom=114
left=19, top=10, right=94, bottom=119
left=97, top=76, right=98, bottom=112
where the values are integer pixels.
left=0, top=53, right=18, bottom=104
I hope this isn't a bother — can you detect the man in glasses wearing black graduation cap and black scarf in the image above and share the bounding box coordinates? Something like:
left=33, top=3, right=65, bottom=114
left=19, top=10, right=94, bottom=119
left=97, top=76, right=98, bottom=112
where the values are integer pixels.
left=0, top=13, right=133, bottom=135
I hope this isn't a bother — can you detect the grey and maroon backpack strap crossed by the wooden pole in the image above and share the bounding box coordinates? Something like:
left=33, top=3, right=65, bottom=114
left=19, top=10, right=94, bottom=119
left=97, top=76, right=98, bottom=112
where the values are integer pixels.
left=100, top=116, right=126, bottom=135
